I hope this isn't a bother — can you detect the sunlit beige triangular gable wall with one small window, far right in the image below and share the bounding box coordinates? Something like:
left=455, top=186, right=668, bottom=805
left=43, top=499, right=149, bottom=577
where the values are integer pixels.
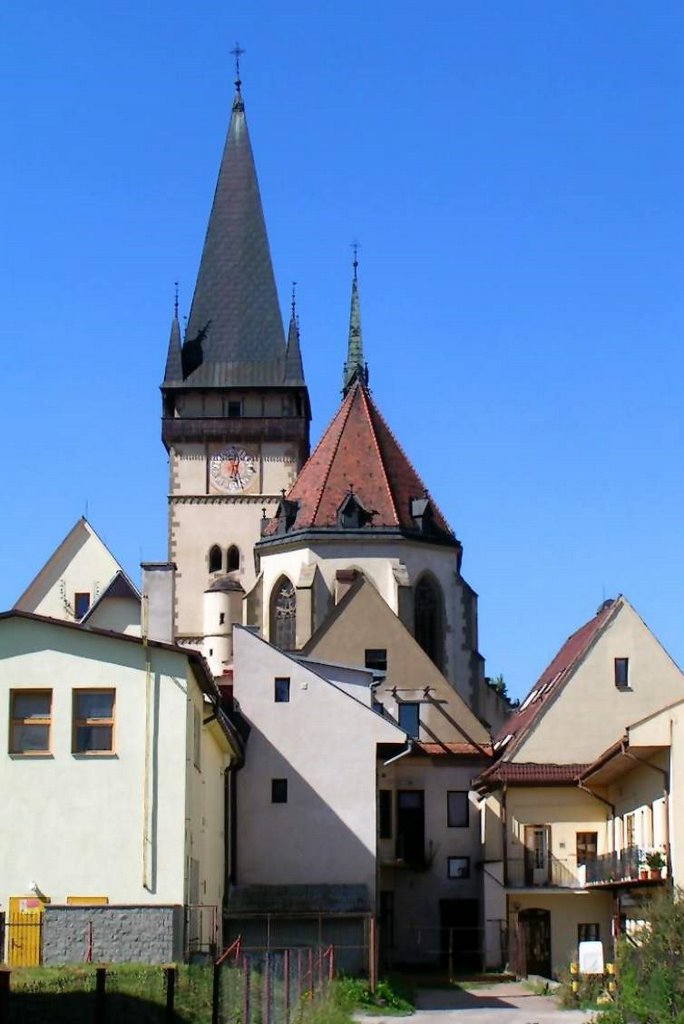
left=511, top=599, right=684, bottom=764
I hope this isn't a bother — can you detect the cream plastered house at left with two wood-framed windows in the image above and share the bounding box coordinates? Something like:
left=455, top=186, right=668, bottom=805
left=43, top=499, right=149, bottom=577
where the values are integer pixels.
left=0, top=611, right=242, bottom=964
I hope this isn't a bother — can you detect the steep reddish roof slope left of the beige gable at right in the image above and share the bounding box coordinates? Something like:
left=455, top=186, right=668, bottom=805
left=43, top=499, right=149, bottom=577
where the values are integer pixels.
left=495, top=596, right=624, bottom=758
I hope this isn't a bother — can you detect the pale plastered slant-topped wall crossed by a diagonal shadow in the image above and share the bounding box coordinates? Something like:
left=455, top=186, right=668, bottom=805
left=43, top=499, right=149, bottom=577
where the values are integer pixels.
left=233, top=627, right=405, bottom=905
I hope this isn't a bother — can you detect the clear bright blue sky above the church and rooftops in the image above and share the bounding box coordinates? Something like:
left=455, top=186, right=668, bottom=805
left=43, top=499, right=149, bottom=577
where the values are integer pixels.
left=0, top=0, right=684, bottom=693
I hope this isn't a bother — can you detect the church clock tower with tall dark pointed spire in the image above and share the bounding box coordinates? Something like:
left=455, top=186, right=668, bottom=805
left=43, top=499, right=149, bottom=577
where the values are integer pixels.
left=162, top=66, right=310, bottom=644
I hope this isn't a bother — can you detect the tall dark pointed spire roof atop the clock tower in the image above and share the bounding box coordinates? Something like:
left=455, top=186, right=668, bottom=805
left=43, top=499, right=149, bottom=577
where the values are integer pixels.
left=164, top=83, right=294, bottom=386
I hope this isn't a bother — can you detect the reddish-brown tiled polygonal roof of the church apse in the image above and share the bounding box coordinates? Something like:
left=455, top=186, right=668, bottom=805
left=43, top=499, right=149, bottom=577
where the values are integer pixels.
left=264, top=382, right=457, bottom=544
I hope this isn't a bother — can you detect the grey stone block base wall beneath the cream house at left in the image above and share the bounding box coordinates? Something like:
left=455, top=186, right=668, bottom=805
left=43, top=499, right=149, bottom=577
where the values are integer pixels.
left=43, top=905, right=183, bottom=964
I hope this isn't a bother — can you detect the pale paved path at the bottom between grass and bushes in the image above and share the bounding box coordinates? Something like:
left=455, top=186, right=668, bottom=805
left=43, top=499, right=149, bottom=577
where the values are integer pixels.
left=356, top=981, right=593, bottom=1024
